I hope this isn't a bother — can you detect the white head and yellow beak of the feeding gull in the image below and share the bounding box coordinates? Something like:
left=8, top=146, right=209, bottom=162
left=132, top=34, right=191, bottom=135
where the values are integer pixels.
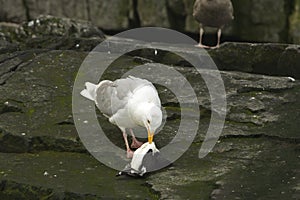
left=143, top=103, right=162, bottom=144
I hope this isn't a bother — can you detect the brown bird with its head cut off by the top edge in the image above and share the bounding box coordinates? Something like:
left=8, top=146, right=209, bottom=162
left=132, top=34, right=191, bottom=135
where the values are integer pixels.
left=193, top=0, right=233, bottom=48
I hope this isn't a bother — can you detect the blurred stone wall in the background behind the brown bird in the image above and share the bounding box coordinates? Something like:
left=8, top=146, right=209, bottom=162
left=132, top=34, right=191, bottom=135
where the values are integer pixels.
left=0, top=0, right=300, bottom=44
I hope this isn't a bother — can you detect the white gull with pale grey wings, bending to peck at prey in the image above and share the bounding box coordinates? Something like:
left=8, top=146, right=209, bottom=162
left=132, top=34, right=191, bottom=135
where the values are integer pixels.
left=80, top=76, right=162, bottom=158
